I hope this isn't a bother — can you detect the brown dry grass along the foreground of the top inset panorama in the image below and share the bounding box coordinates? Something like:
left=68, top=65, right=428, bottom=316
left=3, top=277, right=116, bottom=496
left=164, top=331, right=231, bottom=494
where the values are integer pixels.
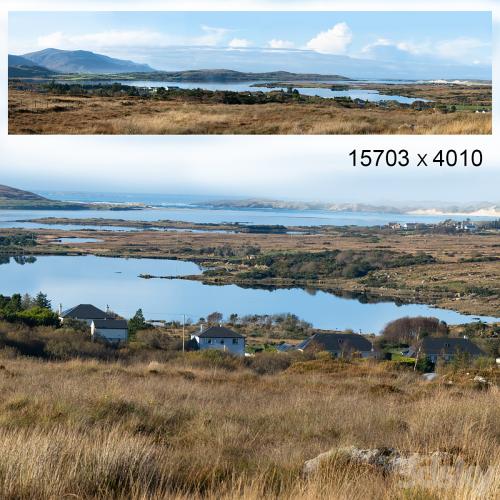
left=9, top=89, right=492, bottom=134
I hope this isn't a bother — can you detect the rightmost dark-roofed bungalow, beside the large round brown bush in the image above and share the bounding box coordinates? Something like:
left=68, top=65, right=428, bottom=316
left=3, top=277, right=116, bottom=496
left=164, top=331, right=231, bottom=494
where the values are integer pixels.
left=408, top=337, right=484, bottom=363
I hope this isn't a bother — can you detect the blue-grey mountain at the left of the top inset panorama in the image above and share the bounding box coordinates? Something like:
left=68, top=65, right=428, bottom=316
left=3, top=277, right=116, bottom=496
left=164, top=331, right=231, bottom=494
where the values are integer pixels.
left=22, top=49, right=154, bottom=73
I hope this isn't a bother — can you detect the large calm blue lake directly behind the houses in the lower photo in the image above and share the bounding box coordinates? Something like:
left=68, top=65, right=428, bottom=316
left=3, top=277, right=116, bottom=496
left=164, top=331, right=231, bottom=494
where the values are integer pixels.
left=0, top=256, right=495, bottom=333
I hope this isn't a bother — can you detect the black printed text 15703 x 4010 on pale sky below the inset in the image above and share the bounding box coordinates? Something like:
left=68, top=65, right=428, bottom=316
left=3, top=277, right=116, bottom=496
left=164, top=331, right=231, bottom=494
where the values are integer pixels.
left=349, top=149, right=483, bottom=167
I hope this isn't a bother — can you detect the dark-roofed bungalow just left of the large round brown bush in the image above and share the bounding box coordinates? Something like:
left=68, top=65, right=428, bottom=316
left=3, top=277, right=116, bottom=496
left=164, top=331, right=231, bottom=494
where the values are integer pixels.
left=297, top=333, right=375, bottom=358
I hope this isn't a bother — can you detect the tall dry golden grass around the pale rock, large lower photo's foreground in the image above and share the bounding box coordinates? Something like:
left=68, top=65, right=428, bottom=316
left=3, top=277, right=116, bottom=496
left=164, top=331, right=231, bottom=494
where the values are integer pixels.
left=0, top=358, right=500, bottom=499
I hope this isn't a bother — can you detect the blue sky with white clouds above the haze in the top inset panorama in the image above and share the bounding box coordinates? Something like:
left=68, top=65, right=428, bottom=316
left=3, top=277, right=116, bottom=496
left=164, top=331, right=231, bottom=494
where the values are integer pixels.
left=9, top=12, right=492, bottom=69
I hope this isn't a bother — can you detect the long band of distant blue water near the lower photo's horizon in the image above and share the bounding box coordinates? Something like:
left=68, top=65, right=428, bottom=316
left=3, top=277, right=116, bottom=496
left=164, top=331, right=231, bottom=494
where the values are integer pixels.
left=0, top=207, right=492, bottom=231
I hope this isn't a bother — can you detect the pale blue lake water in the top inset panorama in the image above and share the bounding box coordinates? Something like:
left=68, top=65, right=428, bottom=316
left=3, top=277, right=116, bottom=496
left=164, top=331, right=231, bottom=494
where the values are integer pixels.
left=105, top=80, right=425, bottom=104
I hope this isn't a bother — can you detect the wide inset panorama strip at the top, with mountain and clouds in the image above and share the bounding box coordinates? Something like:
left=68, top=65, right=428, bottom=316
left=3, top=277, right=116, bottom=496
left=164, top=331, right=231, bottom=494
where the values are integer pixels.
left=8, top=11, right=492, bottom=135
